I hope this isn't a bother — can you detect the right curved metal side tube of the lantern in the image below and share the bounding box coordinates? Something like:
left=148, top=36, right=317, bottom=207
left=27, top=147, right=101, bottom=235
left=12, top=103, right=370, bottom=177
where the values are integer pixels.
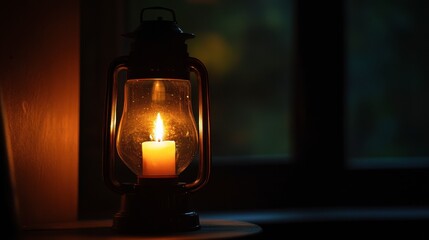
left=184, top=57, right=211, bottom=192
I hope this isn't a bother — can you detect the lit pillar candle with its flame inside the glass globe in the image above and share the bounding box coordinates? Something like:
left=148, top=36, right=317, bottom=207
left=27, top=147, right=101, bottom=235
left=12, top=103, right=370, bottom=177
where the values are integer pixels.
left=142, top=113, right=176, bottom=178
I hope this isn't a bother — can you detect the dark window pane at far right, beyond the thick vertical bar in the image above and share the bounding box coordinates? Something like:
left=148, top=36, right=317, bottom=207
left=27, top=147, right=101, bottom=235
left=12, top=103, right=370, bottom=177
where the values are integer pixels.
left=346, top=0, right=429, bottom=167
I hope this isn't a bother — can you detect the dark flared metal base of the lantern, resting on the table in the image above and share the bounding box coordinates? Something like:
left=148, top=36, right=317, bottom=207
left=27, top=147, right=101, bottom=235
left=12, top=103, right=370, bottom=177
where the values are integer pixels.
left=113, top=178, right=200, bottom=233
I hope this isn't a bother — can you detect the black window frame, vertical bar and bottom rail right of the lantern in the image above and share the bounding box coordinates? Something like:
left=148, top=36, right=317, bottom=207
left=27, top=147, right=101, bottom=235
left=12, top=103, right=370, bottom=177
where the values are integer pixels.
left=192, top=0, right=429, bottom=210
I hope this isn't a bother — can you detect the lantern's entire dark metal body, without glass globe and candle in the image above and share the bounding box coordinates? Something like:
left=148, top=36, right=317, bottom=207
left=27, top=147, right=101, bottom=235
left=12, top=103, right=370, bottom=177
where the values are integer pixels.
left=103, top=7, right=211, bottom=232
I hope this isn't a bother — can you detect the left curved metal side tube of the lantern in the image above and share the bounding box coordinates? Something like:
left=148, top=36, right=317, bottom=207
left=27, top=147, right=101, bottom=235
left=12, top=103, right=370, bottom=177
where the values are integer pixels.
left=103, top=56, right=133, bottom=194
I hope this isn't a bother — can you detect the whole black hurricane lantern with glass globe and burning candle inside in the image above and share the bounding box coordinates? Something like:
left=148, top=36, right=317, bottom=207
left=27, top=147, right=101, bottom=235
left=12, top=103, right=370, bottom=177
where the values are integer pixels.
left=103, top=7, right=211, bottom=232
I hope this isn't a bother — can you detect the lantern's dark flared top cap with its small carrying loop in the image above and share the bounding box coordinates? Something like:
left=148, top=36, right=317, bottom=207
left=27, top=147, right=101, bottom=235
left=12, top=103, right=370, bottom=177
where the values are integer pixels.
left=123, top=7, right=194, bottom=41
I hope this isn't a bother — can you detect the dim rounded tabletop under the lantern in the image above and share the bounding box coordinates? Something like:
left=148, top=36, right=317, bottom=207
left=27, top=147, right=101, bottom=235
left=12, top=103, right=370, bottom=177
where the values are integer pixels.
left=19, top=218, right=262, bottom=240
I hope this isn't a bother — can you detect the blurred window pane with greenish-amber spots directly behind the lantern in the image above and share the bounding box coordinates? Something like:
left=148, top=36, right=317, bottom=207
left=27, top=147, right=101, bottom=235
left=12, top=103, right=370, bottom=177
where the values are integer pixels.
left=123, top=0, right=293, bottom=159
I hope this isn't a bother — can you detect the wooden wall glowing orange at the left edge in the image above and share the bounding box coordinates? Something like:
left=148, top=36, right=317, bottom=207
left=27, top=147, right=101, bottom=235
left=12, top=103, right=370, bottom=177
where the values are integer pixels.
left=0, top=0, right=80, bottom=225
